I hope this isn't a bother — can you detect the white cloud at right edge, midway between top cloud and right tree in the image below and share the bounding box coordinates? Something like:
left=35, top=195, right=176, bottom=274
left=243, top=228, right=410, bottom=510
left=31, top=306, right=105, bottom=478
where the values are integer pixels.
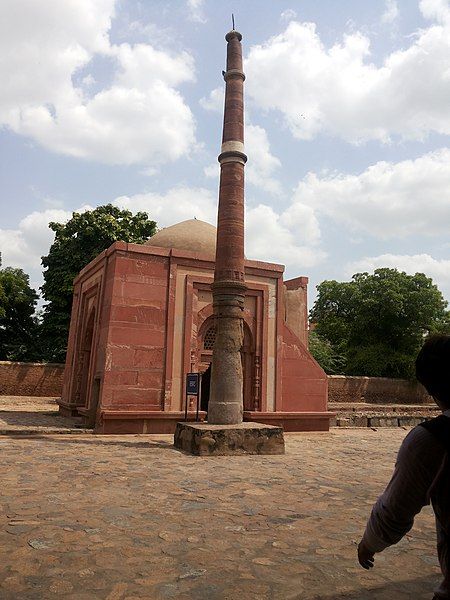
left=296, top=148, right=450, bottom=239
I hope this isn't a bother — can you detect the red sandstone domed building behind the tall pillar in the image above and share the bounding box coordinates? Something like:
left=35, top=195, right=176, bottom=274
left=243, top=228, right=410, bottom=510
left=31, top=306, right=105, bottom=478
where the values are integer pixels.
left=60, top=220, right=331, bottom=433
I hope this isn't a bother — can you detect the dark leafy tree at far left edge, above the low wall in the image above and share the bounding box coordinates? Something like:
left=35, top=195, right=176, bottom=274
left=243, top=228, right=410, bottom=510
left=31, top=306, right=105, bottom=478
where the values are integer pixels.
left=0, top=257, right=40, bottom=360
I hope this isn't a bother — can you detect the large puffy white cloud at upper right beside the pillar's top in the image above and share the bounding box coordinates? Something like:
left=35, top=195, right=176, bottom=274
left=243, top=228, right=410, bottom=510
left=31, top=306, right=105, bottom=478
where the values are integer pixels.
left=245, top=10, right=450, bottom=143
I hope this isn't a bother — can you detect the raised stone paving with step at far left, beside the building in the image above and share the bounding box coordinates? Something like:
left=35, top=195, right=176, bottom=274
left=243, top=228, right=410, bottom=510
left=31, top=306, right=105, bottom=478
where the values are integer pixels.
left=0, top=396, right=86, bottom=435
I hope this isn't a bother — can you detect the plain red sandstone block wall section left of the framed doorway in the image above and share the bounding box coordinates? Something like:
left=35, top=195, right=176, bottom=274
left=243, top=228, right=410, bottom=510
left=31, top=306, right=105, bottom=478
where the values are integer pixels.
left=98, top=246, right=170, bottom=411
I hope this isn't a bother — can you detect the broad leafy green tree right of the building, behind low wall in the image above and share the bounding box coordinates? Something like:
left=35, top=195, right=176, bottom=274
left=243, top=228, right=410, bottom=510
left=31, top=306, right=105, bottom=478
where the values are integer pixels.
left=310, top=268, right=450, bottom=377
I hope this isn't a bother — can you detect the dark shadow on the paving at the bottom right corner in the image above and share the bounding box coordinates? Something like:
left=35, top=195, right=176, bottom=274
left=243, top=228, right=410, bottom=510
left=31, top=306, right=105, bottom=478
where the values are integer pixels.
left=306, top=575, right=440, bottom=600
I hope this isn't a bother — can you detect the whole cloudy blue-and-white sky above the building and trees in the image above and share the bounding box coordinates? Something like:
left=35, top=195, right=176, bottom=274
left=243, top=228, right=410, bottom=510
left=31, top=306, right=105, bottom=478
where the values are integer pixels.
left=0, top=0, right=450, bottom=308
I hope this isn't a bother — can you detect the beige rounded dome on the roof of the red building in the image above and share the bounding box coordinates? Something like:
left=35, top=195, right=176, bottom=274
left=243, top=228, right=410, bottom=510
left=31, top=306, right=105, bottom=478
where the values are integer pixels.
left=145, top=219, right=216, bottom=258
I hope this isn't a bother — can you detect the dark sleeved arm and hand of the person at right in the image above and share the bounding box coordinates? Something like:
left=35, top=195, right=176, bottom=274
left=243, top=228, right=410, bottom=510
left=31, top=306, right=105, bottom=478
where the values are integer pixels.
left=358, top=427, right=443, bottom=569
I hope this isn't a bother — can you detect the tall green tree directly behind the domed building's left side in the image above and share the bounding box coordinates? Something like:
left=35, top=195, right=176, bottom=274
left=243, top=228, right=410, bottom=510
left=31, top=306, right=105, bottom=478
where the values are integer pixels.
left=41, top=204, right=156, bottom=362
